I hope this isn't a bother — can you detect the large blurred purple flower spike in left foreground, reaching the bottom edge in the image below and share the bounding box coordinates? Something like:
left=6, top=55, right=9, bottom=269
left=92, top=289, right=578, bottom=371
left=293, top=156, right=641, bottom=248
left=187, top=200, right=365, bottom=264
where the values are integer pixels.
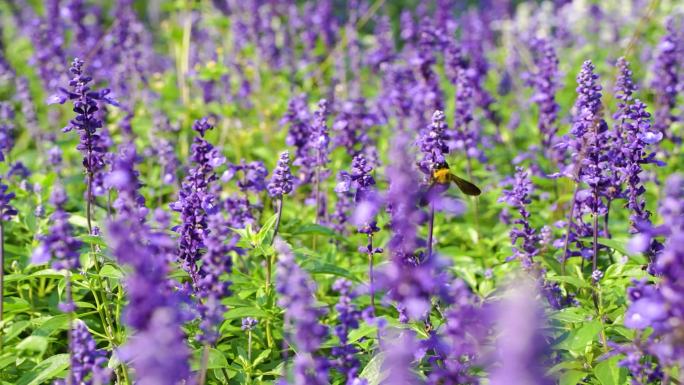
left=107, top=157, right=190, bottom=385
